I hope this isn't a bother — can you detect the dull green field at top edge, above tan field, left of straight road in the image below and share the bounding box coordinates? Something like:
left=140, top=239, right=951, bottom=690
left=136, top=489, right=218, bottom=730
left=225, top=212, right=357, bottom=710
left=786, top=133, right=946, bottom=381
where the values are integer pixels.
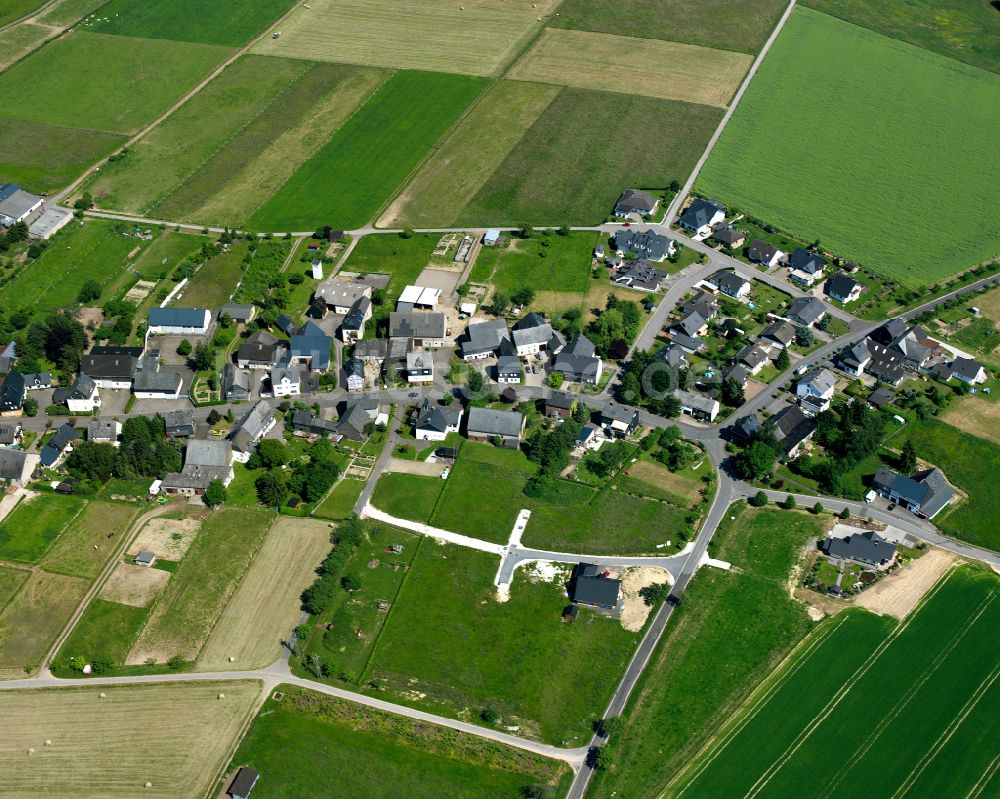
left=548, top=0, right=786, bottom=53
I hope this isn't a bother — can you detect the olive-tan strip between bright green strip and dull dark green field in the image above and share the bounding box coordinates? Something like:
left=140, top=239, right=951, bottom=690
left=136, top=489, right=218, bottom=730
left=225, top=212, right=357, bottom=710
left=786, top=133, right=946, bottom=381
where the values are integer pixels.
left=379, top=80, right=560, bottom=227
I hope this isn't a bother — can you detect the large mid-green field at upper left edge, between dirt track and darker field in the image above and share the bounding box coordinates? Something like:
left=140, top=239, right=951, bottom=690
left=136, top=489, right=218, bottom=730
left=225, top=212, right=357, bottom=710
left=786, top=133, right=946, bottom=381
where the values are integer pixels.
left=0, top=31, right=230, bottom=133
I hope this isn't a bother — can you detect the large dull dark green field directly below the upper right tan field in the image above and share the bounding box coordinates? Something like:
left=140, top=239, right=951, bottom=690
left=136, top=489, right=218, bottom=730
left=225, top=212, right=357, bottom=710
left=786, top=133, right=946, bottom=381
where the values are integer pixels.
left=457, top=89, right=722, bottom=226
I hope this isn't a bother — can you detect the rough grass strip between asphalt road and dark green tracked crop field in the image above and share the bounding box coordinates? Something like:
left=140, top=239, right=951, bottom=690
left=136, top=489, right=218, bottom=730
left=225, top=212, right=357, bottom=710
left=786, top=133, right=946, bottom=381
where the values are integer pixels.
left=591, top=503, right=820, bottom=799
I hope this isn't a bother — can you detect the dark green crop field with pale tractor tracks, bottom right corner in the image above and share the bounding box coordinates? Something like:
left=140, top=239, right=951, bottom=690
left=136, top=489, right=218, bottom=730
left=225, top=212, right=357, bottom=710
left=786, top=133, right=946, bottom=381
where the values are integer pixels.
left=668, top=567, right=1000, bottom=799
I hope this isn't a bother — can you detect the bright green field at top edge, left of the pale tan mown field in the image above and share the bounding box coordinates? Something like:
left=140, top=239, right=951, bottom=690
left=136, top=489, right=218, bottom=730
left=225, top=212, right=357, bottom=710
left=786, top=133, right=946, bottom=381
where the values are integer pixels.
left=87, top=0, right=292, bottom=47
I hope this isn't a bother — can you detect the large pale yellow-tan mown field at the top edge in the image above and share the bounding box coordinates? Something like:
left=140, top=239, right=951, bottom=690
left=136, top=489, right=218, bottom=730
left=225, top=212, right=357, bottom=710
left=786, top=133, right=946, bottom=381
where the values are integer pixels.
left=255, top=0, right=558, bottom=76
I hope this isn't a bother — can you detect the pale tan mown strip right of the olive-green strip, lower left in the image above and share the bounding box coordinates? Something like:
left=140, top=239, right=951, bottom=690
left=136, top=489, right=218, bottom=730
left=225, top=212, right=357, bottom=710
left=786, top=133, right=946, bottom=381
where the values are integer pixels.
left=198, top=516, right=330, bottom=670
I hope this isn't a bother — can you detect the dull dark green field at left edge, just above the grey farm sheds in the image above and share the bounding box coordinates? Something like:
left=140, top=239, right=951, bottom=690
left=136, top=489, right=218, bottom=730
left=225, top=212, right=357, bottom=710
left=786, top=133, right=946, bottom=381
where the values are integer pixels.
left=0, top=119, right=125, bottom=193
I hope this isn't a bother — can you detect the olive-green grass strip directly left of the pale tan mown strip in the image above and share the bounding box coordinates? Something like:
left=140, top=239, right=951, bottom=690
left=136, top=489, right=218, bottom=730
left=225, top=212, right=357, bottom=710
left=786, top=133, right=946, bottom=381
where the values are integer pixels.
left=128, top=508, right=274, bottom=663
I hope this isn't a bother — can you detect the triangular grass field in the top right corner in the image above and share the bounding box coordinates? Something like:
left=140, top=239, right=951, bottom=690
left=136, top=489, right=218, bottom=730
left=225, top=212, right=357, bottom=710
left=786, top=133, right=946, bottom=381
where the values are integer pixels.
left=805, top=0, right=1000, bottom=72
